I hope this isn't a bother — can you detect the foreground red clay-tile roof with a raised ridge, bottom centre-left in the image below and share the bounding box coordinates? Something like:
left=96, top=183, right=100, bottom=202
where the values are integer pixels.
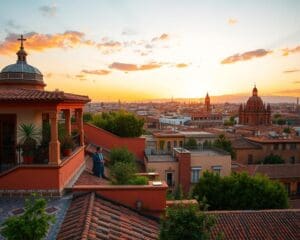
left=57, top=193, right=159, bottom=240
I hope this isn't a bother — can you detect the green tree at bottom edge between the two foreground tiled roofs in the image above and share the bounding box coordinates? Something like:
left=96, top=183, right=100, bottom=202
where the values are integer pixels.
left=159, top=204, right=216, bottom=240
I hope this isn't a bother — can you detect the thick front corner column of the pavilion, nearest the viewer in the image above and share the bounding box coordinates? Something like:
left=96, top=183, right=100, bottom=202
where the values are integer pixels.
left=49, top=112, right=60, bottom=165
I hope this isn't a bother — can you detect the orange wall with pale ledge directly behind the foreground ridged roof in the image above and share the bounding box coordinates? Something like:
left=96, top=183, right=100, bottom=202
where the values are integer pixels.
left=73, top=182, right=168, bottom=216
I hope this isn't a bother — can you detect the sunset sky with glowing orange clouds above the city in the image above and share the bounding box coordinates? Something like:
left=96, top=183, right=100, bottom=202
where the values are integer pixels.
left=0, top=0, right=300, bottom=101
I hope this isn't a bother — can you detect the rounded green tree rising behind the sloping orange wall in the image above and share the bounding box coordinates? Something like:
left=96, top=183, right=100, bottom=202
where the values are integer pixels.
left=91, top=111, right=144, bottom=137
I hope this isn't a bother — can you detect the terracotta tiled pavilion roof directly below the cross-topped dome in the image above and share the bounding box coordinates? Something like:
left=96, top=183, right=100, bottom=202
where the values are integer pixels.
left=0, top=88, right=90, bottom=103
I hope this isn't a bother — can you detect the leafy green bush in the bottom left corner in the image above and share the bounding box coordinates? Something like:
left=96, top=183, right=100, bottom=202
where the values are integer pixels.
left=1, top=196, right=55, bottom=240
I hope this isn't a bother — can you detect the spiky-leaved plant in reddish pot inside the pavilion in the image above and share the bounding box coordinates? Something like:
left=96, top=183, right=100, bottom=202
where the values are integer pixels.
left=18, top=123, right=40, bottom=164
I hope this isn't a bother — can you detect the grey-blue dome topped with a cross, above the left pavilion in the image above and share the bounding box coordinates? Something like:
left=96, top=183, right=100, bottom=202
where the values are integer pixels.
left=0, top=35, right=46, bottom=90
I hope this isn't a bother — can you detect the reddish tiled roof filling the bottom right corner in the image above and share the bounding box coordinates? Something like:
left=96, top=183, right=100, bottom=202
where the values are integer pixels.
left=211, top=209, right=300, bottom=240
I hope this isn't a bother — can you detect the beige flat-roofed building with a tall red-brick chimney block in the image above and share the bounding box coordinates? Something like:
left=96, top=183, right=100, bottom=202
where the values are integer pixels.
left=145, top=148, right=231, bottom=193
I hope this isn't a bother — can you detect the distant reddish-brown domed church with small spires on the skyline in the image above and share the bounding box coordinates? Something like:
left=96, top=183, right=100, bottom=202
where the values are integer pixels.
left=239, top=86, right=271, bottom=125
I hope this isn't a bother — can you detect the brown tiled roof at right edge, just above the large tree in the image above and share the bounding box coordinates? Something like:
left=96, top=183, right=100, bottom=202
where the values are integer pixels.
left=254, top=164, right=300, bottom=179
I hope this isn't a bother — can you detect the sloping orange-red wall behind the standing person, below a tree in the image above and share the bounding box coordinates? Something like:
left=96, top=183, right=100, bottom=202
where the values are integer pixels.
left=83, top=123, right=145, bottom=160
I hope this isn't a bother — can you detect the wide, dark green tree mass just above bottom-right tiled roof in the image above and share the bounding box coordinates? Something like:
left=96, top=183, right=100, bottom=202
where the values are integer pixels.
left=193, top=172, right=288, bottom=210
